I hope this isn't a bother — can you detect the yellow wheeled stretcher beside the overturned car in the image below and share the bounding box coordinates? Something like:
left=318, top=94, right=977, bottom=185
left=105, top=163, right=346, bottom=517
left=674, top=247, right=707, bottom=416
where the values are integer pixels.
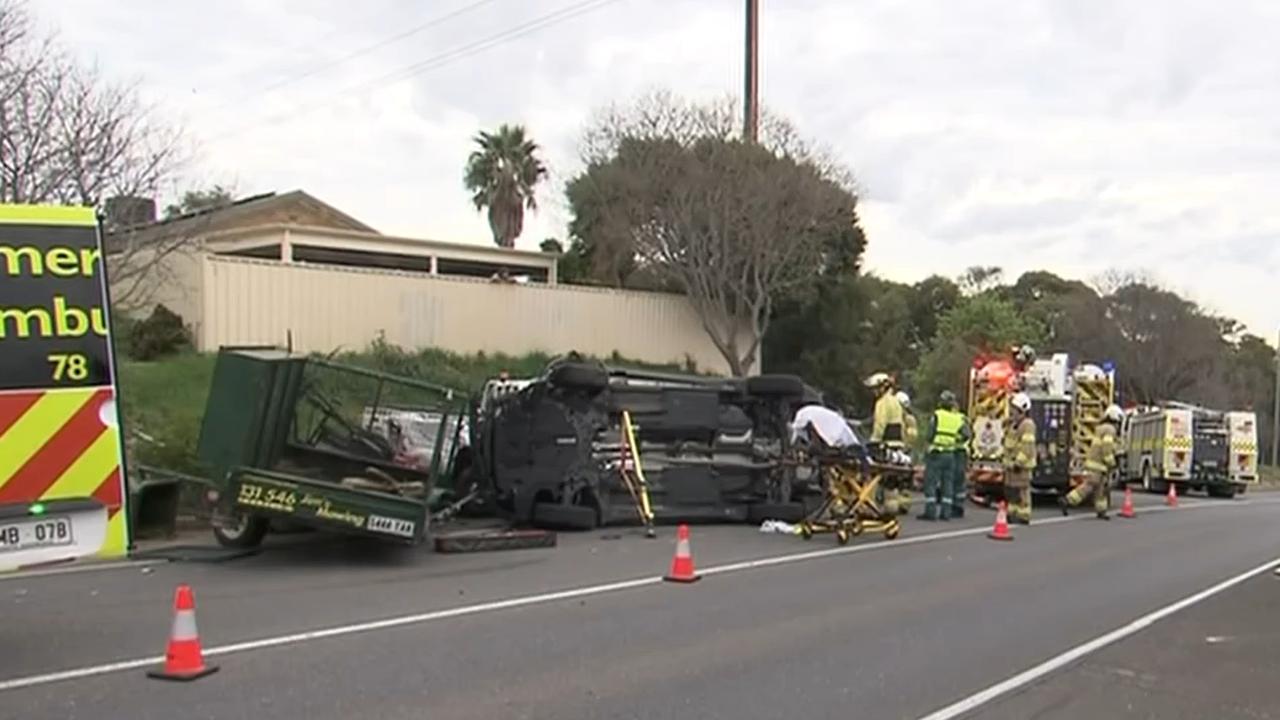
left=799, top=442, right=914, bottom=544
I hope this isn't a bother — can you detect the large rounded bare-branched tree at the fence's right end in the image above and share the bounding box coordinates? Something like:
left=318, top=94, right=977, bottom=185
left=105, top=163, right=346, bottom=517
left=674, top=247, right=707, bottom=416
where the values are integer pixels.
left=568, top=94, right=861, bottom=375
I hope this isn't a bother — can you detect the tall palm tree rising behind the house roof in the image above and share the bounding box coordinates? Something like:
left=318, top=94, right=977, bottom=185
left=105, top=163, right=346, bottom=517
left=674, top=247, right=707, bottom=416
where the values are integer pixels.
left=462, top=124, right=547, bottom=247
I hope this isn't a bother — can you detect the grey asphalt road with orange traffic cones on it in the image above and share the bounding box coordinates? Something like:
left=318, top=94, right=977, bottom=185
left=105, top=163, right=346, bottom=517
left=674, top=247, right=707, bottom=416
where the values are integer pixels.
left=0, top=495, right=1280, bottom=720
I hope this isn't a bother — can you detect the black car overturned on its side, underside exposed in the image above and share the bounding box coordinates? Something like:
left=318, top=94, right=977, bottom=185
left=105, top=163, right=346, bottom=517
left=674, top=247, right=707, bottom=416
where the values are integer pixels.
left=468, top=357, right=822, bottom=529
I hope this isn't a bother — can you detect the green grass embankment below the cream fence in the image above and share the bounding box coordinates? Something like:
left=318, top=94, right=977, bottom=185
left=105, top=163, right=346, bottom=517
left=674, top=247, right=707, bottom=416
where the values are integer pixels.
left=120, top=342, right=695, bottom=475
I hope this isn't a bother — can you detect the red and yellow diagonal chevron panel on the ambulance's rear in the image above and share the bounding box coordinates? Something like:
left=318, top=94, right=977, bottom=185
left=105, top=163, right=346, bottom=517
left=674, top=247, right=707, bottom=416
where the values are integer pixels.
left=0, top=387, right=127, bottom=556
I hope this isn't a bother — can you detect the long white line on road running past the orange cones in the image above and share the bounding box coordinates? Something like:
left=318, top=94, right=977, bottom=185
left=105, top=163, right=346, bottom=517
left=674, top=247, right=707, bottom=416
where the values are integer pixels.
left=0, top=491, right=1280, bottom=692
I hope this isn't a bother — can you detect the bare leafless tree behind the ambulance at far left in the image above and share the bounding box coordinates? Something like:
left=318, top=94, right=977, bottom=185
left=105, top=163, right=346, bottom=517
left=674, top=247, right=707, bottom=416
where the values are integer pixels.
left=0, top=0, right=189, bottom=310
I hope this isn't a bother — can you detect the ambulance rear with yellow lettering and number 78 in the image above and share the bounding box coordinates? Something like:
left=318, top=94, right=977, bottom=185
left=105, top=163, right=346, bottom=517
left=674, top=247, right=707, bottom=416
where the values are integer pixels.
left=0, top=205, right=129, bottom=571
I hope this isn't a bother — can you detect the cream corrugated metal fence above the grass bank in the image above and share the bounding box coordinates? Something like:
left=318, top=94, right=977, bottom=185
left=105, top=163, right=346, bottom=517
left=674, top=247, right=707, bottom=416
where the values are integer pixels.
left=192, top=255, right=742, bottom=373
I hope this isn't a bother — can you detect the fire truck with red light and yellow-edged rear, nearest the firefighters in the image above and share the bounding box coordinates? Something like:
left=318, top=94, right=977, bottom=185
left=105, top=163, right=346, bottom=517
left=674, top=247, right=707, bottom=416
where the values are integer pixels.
left=966, top=347, right=1115, bottom=505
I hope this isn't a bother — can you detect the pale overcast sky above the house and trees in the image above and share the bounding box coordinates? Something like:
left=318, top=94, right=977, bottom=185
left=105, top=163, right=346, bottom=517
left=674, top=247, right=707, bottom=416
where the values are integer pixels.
left=32, top=0, right=1280, bottom=337
